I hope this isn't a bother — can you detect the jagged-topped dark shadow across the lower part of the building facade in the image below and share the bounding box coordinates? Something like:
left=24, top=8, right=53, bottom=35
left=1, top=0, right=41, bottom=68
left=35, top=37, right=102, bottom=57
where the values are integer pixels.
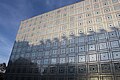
left=6, top=28, right=120, bottom=80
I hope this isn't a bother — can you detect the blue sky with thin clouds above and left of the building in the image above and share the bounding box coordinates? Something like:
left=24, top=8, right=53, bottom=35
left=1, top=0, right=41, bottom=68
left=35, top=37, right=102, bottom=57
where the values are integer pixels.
left=0, top=0, right=80, bottom=63
